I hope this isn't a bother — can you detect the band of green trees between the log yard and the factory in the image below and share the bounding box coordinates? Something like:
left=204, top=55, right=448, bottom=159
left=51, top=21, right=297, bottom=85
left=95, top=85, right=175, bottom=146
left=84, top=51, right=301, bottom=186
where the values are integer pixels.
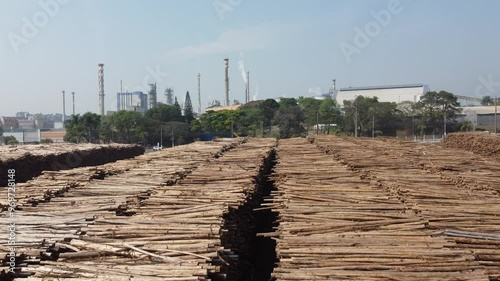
left=65, top=91, right=472, bottom=146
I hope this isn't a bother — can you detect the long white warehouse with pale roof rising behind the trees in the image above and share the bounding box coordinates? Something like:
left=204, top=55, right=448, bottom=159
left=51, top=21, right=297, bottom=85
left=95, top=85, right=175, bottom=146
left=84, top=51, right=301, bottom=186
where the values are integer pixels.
left=337, top=84, right=429, bottom=107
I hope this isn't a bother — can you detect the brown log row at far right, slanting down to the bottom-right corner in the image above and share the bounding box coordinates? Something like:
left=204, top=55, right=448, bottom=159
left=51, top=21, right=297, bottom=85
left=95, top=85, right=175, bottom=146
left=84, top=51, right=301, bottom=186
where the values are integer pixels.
left=315, top=137, right=500, bottom=280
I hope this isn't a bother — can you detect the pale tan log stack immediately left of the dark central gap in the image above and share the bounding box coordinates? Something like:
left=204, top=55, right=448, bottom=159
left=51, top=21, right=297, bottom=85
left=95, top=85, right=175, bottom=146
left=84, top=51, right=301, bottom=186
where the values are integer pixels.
left=2, top=140, right=275, bottom=281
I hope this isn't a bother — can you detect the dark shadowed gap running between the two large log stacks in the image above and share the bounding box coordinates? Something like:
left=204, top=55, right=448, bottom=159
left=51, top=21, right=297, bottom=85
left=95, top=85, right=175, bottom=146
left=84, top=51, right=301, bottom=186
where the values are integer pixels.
left=209, top=148, right=278, bottom=281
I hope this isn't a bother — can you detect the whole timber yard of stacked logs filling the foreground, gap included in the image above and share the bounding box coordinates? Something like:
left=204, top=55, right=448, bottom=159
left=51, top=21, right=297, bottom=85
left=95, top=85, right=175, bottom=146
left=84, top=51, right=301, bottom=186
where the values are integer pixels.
left=0, top=133, right=500, bottom=281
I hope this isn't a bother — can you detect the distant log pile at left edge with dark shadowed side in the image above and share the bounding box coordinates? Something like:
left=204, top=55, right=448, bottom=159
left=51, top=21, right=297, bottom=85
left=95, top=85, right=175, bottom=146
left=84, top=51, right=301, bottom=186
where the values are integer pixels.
left=0, top=144, right=144, bottom=186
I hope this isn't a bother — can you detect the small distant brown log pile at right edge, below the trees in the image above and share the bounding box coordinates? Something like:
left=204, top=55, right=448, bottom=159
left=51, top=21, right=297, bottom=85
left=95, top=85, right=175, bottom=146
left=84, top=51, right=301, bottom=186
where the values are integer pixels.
left=442, top=133, right=500, bottom=157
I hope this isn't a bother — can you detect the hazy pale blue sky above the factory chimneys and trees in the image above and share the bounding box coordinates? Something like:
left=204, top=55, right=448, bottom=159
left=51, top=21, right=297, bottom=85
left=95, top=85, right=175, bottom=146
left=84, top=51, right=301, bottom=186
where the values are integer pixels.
left=0, top=0, right=500, bottom=116
